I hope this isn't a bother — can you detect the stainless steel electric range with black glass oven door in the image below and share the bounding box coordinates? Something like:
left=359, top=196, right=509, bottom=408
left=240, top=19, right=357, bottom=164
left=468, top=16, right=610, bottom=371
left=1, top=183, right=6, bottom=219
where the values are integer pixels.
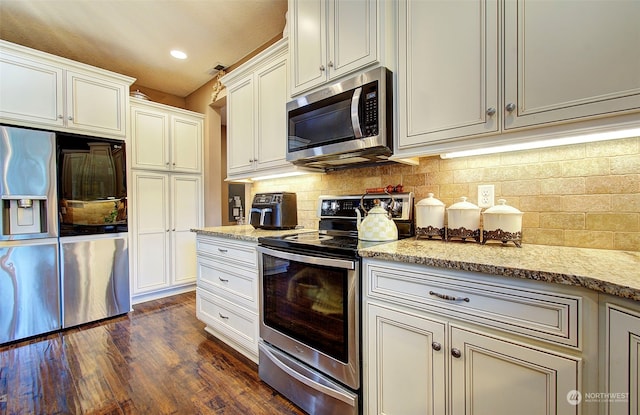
left=258, top=193, right=413, bottom=415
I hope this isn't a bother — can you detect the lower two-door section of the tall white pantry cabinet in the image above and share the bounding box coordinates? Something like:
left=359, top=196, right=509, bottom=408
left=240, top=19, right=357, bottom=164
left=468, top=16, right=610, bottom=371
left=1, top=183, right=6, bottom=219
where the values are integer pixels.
left=132, top=170, right=203, bottom=302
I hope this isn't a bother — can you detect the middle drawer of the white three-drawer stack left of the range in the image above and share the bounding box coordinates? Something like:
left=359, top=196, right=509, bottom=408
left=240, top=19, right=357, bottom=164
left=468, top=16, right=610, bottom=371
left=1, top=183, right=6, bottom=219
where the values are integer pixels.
left=198, top=255, right=258, bottom=311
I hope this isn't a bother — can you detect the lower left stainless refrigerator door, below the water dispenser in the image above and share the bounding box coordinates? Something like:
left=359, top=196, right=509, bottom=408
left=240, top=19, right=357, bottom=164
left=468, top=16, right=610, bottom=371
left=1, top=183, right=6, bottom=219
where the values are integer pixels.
left=0, top=238, right=60, bottom=343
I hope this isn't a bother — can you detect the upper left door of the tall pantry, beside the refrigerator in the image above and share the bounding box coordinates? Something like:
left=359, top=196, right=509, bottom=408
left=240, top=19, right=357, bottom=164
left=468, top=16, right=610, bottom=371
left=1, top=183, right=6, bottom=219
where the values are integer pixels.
left=131, top=105, right=169, bottom=170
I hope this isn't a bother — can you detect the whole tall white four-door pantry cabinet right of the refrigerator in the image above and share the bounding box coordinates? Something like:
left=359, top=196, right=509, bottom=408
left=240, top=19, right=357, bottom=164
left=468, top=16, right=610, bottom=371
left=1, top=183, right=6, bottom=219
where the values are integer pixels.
left=130, top=98, right=204, bottom=303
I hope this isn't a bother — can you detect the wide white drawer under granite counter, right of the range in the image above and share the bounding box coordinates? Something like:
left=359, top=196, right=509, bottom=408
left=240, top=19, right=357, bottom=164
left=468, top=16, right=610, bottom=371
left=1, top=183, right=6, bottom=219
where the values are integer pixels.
left=366, top=263, right=582, bottom=348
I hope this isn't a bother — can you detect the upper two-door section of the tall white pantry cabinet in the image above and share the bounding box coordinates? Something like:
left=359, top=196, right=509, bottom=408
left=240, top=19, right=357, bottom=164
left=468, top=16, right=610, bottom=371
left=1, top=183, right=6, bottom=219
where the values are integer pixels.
left=131, top=98, right=204, bottom=173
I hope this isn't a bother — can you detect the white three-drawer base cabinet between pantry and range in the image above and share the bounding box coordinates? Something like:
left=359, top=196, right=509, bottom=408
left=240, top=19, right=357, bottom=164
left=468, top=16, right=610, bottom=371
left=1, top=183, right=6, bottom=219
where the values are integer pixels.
left=196, top=234, right=259, bottom=363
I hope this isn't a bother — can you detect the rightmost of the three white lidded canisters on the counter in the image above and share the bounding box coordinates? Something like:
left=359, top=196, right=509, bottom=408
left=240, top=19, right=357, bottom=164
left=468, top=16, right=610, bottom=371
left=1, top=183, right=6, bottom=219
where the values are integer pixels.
left=482, top=199, right=523, bottom=248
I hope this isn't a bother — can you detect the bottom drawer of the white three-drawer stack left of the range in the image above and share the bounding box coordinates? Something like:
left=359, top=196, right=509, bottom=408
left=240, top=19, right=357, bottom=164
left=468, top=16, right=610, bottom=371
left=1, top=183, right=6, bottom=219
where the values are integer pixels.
left=196, top=288, right=258, bottom=356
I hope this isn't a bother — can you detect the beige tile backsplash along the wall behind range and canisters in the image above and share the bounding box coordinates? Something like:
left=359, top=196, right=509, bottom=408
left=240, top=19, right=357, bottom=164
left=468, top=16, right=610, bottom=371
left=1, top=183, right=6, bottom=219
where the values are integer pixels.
left=252, top=137, right=640, bottom=251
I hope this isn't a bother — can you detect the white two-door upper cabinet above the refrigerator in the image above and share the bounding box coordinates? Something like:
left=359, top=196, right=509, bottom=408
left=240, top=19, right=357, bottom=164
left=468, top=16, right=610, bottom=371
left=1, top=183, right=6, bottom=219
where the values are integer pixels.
left=0, top=41, right=134, bottom=138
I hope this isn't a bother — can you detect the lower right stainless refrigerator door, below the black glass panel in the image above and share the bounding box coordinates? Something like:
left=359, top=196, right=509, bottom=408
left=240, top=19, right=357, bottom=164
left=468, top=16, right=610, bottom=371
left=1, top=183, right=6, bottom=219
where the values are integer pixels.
left=60, top=233, right=131, bottom=328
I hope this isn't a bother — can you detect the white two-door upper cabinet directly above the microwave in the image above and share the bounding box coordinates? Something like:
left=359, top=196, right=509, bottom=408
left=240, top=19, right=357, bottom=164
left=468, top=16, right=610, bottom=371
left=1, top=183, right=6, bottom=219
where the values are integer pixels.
left=289, top=0, right=381, bottom=95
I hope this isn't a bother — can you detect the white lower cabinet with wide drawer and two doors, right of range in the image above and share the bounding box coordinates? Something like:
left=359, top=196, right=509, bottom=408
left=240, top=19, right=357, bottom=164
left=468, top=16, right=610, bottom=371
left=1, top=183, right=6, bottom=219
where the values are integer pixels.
left=363, top=259, right=597, bottom=415
